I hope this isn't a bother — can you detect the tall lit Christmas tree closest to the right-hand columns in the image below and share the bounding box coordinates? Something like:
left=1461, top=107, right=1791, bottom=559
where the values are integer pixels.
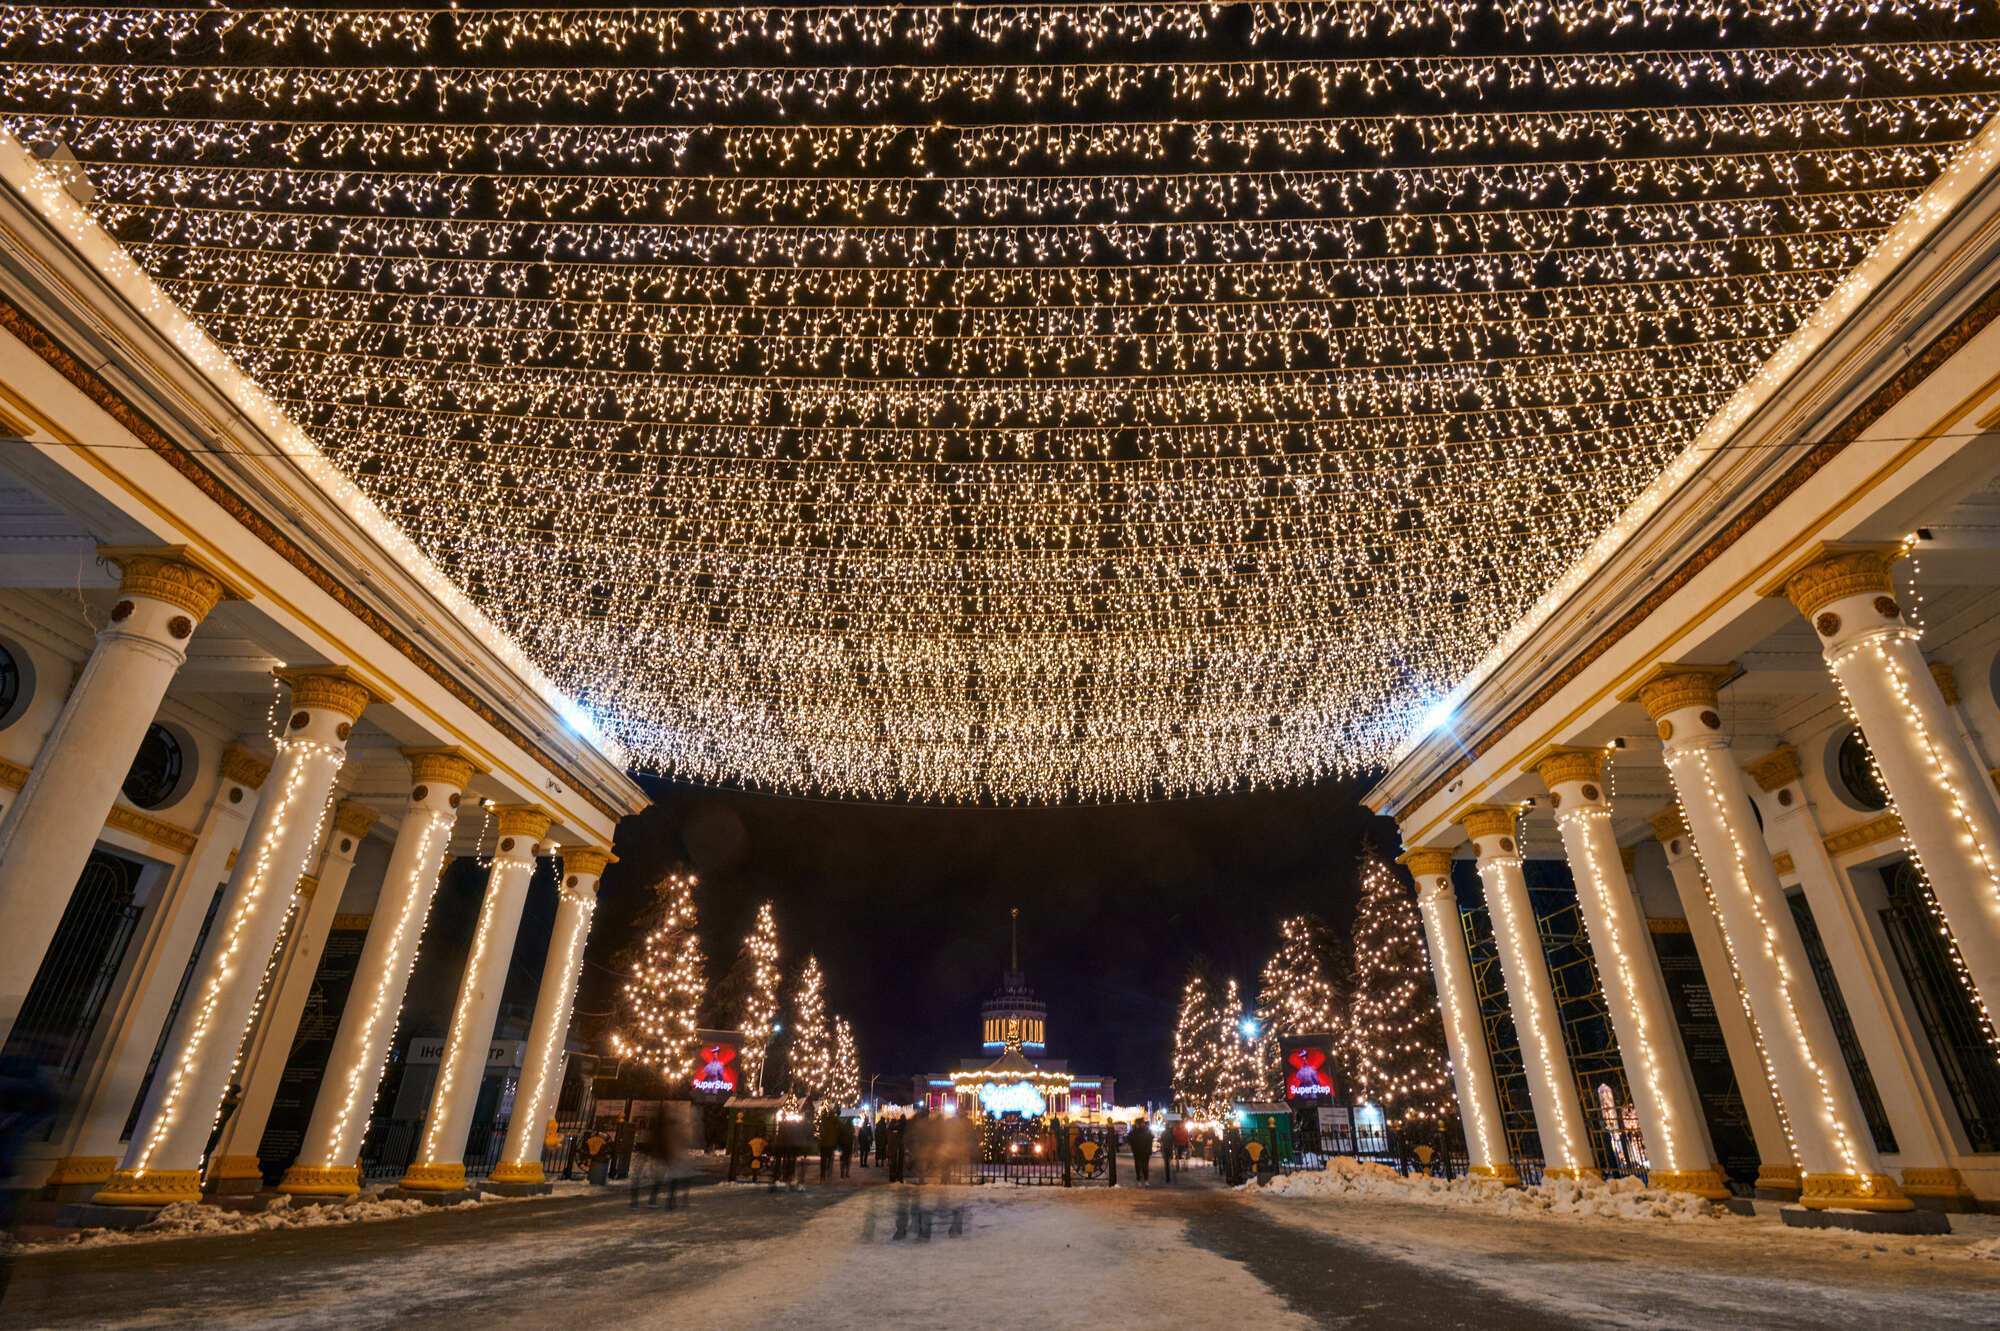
left=1348, top=855, right=1456, bottom=1129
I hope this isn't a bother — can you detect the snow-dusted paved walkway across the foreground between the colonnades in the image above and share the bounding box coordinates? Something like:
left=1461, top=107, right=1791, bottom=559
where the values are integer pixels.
left=0, top=1171, right=2000, bottom=1331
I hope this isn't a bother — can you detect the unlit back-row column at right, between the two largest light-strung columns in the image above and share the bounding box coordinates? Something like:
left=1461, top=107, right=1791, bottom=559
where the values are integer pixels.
left=1744, top=745, right=1972, bottom=1201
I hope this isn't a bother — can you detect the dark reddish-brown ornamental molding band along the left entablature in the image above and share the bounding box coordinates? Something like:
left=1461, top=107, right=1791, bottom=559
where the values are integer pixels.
left=0, top=296, right=624, bottom=821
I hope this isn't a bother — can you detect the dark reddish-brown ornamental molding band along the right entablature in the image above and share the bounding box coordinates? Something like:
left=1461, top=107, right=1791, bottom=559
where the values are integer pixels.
left=1400, top=284, right=2000, bottom=809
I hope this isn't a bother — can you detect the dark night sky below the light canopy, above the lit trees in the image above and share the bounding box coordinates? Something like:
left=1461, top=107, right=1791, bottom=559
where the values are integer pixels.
left=488, top=779, right=1394, bottom=1103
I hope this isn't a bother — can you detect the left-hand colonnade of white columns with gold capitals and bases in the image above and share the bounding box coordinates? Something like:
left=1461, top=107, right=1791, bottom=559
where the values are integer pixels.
left=0, top=550, right=612, bottom=1207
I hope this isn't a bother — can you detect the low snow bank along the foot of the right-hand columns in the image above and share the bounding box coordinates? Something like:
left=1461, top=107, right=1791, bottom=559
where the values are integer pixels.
left=1264, top=1155, right=1716, bottom=1223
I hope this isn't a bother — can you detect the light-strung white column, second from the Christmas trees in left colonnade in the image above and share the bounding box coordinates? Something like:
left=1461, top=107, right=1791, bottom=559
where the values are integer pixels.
left=398, top=803, right=552, bottom=1193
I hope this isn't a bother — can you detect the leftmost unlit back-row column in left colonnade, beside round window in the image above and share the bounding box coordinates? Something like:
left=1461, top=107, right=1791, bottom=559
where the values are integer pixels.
left=46, top=743, right=270, bottom=1201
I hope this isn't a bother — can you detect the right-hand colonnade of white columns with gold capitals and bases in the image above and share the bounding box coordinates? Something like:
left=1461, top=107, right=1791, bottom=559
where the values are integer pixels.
left=1404, top=548, right=2000, bottom=1211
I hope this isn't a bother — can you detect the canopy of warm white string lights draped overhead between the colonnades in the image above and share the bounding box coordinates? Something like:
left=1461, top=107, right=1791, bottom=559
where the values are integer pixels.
left=0, top=0, right=2000, bottom=801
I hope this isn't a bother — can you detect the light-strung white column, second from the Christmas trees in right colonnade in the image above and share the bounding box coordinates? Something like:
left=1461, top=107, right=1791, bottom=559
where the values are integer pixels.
left=1458, top=805, right=1598, bottom=1179
